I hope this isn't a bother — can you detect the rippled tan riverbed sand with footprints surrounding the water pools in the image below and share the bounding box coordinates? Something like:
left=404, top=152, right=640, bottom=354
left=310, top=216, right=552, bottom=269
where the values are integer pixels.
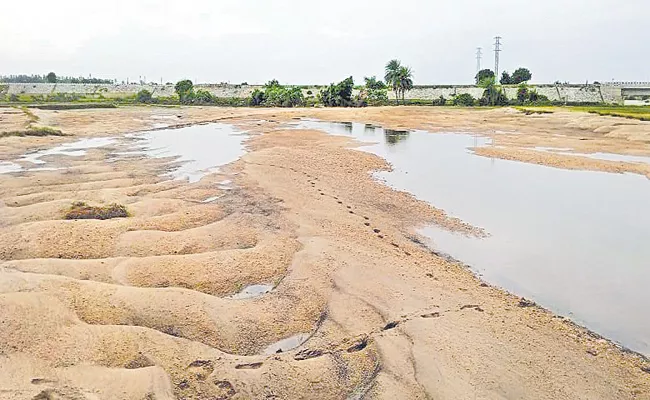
left=0, top=107, right=650, bottom=399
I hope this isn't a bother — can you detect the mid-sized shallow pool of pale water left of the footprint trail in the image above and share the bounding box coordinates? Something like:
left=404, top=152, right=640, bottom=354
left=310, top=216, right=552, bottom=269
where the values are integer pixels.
left=129, top=123, right=248, bottom=183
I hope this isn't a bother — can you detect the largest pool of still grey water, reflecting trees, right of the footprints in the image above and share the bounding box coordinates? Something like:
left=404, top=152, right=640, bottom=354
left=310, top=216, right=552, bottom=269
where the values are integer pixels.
left=296, top=121, right=650, bottom=355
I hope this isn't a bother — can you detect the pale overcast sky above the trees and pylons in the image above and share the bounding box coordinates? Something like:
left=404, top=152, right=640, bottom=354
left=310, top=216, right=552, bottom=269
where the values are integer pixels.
left=0, top=0, right=650, bottom=85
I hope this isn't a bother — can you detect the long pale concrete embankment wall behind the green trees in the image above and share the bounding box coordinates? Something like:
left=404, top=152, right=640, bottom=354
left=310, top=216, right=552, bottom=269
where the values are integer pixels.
left=0, top=83, right=624, bottom=103
